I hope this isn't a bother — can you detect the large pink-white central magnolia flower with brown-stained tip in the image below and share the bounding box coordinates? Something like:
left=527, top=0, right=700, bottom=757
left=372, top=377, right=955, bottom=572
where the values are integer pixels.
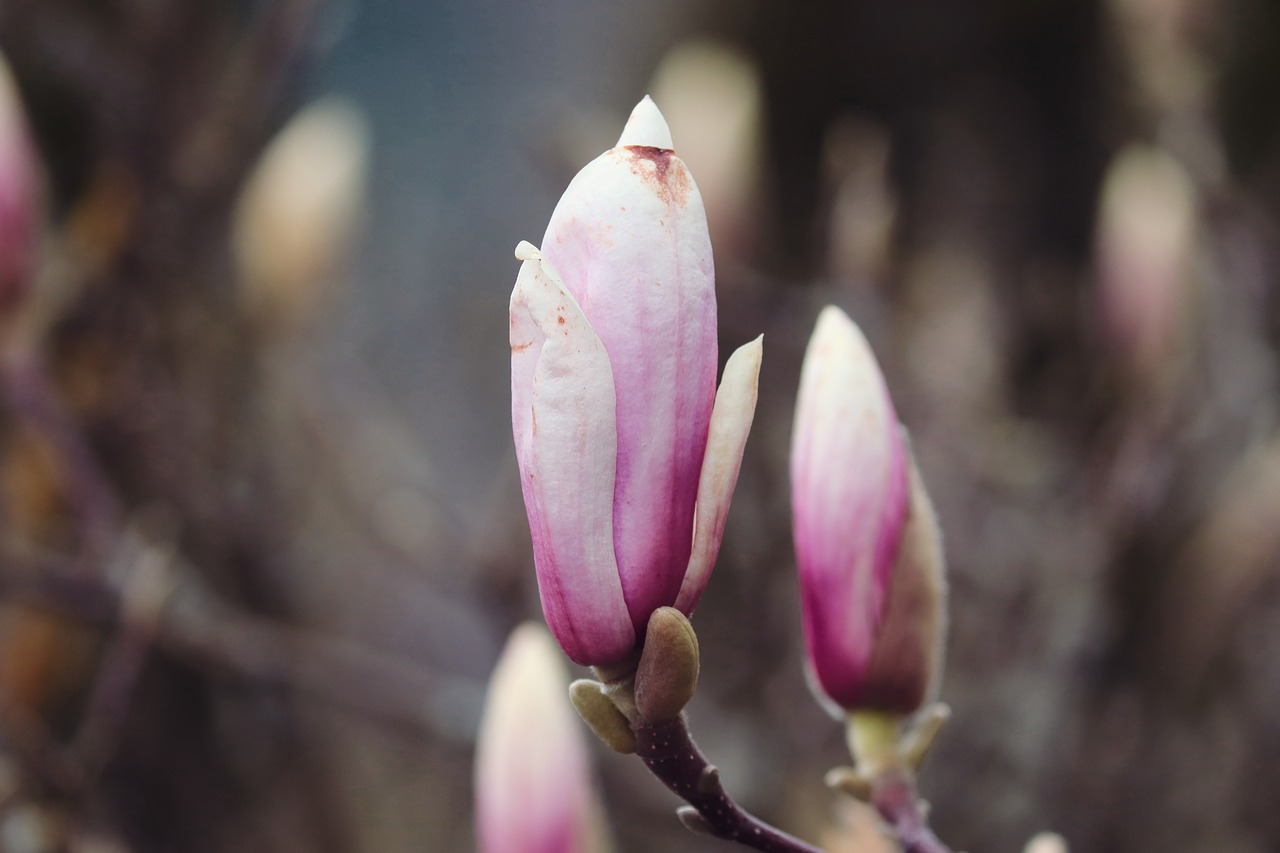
left=511, top=97, right=760, bottom=665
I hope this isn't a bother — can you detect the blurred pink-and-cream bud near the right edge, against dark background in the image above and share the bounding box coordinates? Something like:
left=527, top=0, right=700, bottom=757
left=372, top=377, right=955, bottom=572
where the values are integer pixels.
left=1096, top=145, right=1196, bottom=380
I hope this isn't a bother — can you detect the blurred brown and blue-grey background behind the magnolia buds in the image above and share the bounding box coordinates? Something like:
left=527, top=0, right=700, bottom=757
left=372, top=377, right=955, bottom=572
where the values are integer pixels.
left=0, top=0, right=1280, bottom=853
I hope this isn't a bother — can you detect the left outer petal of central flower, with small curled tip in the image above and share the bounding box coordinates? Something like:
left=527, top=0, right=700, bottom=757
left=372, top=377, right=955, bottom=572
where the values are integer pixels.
left=511, top=243, right=636, bottom=665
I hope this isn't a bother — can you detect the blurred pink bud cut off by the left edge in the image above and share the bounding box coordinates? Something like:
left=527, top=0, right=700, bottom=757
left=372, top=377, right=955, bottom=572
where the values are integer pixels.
left=0, top=56, right=40, bottom=330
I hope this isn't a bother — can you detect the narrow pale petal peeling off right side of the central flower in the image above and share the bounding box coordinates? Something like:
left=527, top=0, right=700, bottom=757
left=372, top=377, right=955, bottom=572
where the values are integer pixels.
left=676, top=336, right=764, bottom=615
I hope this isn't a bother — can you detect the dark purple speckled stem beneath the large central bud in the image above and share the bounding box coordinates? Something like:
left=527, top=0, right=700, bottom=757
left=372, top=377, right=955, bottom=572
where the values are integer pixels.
left=635, top=715, right=824, bottom=853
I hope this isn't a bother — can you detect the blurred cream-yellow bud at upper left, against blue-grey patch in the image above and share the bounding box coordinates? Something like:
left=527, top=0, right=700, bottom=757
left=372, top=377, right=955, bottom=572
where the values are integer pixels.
left=233, top=99, right=369, bottom=332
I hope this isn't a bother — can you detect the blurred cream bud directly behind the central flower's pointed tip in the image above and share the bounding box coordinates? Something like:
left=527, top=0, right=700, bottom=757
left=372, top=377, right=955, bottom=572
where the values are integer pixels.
left=650, top=41, right=763, bottom=260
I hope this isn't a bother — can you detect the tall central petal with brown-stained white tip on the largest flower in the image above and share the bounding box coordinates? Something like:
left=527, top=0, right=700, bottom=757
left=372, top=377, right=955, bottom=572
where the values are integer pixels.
left=543, top=101, right=717, bottom=630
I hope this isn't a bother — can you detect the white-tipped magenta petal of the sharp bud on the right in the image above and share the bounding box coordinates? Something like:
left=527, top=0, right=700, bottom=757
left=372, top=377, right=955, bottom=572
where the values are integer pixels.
left=791, top=307, right=908, bottom=708
